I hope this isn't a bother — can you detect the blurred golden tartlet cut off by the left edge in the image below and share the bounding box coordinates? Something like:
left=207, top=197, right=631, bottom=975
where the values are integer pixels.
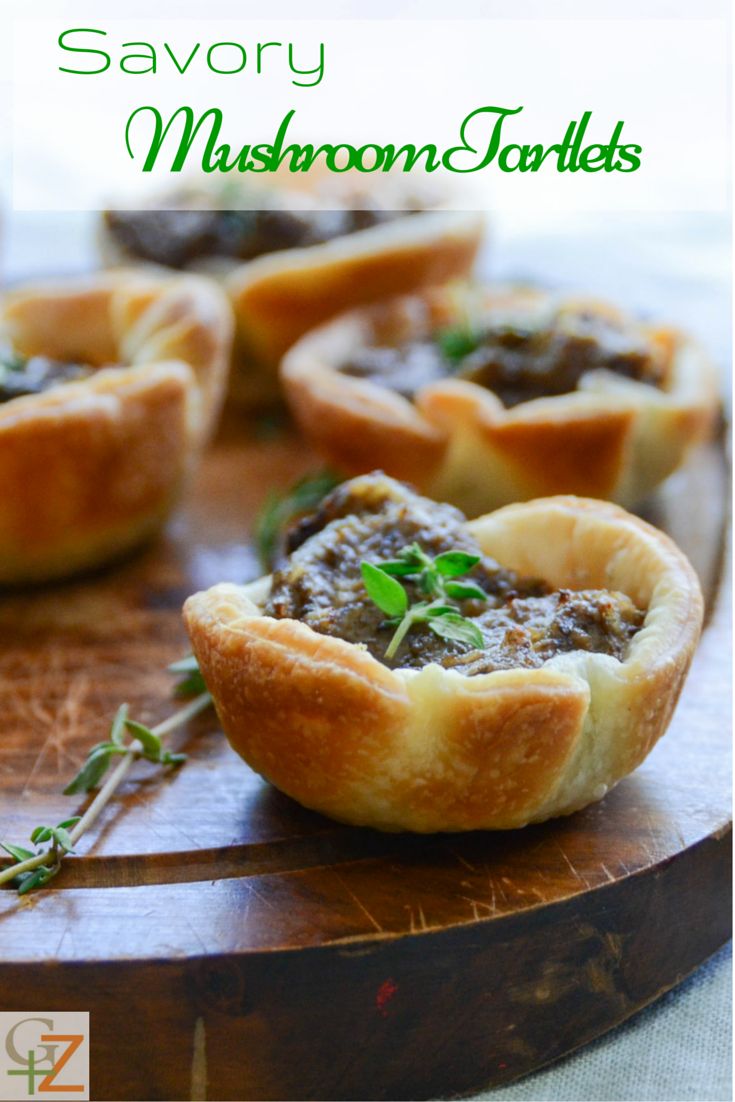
left=0, top=272, right=233, bottom=584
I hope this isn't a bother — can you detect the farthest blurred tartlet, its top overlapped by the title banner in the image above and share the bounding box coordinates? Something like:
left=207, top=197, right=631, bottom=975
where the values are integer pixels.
left=104, top=185, right=484, bottom=406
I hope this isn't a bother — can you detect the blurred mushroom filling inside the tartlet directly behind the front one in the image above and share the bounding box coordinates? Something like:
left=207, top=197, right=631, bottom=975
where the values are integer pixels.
left=341, top=307, right=666, bottom=407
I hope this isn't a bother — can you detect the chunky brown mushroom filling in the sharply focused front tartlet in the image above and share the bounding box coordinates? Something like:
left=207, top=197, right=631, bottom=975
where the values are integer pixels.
left=263, top=473, right=645, bottom=674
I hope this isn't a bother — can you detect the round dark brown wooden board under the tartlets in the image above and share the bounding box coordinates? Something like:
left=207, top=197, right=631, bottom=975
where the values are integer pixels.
left=0, top=423, right=731, bottom=1100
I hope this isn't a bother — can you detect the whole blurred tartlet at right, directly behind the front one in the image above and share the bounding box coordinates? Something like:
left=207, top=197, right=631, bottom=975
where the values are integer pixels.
left=281, top=288, right=718, bottom=516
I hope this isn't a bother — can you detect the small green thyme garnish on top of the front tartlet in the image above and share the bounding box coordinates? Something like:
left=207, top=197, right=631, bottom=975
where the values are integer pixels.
left=360, top=543, right=487, bottom=658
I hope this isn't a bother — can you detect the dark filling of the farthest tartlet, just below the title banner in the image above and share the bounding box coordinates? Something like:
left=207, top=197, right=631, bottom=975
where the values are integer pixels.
left=105, top=208, right=412, bottom=268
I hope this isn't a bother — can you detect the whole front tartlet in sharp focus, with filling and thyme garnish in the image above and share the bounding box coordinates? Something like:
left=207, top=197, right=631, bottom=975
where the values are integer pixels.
left=184, top=475, right=702, bottom=831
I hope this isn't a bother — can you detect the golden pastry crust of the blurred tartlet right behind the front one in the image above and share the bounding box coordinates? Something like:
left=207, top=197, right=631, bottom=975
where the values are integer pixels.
left=281, top=288, right=718, bottom=506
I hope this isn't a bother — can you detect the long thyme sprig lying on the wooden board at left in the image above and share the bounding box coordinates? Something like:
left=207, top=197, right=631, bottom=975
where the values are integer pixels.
left=0, top=657, right=212, bottom=895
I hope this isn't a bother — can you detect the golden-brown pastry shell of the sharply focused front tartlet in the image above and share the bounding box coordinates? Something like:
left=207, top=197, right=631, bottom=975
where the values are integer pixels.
left=184, top=497, right=702, bottom=832
